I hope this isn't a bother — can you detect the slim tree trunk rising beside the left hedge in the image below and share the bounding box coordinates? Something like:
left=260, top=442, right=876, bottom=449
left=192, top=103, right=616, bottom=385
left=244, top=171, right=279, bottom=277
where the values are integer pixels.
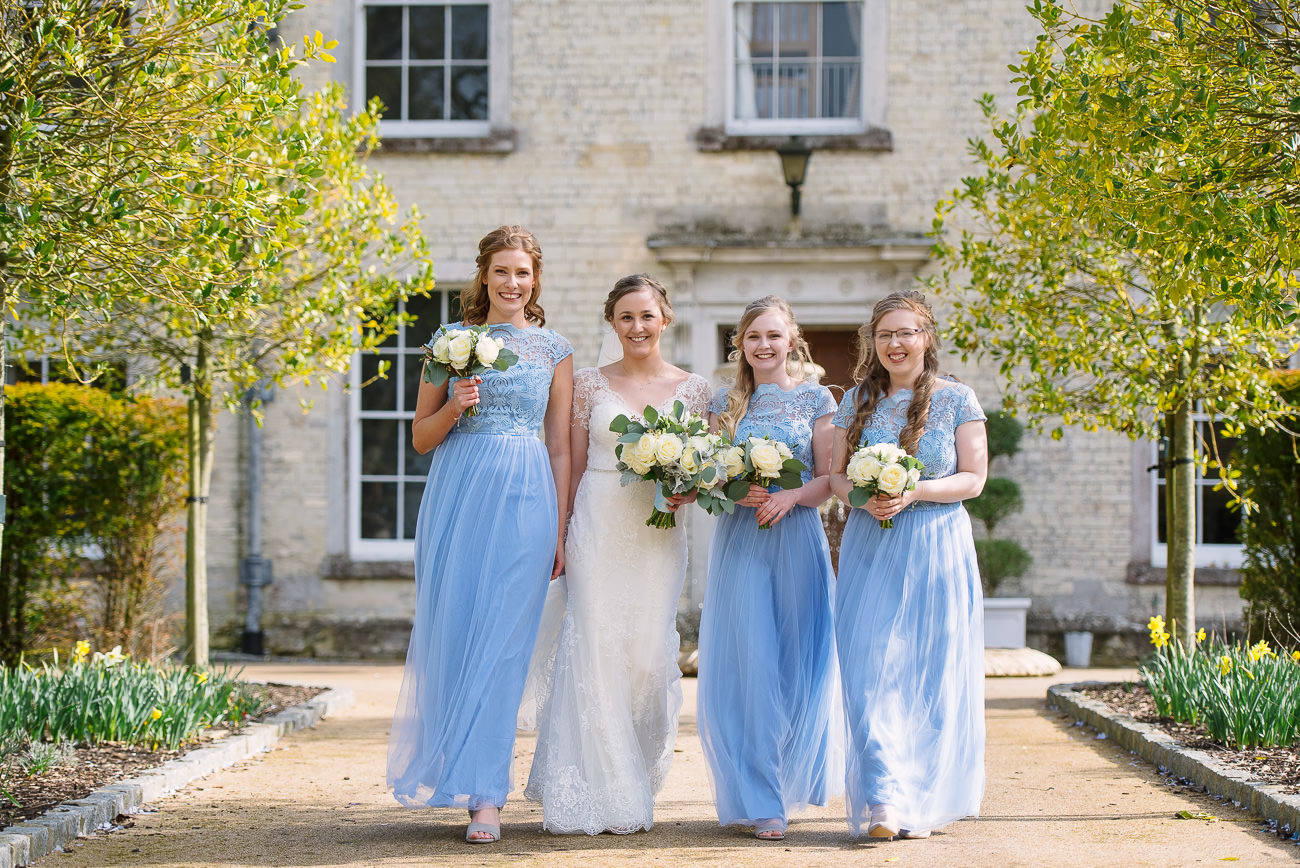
left=185, top=329, right=213, bottom=667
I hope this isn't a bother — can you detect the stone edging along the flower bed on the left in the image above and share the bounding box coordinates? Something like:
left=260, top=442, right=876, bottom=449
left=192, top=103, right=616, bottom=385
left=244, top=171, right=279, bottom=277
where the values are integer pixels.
left=0, top=687, right=352, bottom=868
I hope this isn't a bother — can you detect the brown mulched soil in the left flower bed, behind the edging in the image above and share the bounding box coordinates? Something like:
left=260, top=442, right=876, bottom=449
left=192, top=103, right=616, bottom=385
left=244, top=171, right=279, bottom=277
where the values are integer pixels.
left=0, top=685, right=325, bottom=829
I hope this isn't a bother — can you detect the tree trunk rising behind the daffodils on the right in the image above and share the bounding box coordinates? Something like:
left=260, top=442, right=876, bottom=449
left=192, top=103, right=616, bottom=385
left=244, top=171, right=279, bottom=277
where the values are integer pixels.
left=1165, top=402, right=1196, bottom=648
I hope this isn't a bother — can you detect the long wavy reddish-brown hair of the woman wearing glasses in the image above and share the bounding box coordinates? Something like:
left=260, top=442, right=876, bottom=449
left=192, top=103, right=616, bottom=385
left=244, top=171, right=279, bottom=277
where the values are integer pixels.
left=840, top=290, right=939, bottom=470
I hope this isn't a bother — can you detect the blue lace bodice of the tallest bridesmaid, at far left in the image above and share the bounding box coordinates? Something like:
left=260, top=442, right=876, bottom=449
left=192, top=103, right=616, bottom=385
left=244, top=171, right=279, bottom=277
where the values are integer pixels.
left=429, top=322, right=573, bottom=437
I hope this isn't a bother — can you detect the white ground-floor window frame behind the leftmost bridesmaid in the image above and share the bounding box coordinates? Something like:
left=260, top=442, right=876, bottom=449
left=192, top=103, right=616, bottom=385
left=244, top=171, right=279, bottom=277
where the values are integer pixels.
left=347, top=283, right=456, bottom=561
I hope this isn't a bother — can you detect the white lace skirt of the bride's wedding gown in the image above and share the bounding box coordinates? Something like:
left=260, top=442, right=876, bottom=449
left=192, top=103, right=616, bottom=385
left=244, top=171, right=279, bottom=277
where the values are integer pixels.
left=520, top=469, right=686, bottom=834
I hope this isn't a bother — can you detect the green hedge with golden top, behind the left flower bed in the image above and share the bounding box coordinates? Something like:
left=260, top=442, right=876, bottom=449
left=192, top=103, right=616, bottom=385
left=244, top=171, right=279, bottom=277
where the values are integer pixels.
left=0, top=383, right=186, bottom=665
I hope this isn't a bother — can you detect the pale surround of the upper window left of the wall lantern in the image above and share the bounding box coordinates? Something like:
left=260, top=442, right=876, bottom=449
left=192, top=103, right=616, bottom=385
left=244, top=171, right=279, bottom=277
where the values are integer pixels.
left=352, top=0, right=510, bottom=139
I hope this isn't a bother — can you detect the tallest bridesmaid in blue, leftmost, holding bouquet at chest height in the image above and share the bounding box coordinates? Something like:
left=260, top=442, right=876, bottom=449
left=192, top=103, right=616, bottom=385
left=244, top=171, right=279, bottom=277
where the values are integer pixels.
left=387, top=226, right=573, bottom=843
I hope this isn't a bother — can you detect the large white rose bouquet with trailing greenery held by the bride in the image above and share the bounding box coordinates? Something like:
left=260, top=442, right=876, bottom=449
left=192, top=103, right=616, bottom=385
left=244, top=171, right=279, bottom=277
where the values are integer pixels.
left=610, top=402, right=736, bottom=528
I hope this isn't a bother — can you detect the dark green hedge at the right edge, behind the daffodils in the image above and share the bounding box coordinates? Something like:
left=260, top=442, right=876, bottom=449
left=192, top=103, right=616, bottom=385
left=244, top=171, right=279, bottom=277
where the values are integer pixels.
left=1235, top=370, right=1300, bottom=646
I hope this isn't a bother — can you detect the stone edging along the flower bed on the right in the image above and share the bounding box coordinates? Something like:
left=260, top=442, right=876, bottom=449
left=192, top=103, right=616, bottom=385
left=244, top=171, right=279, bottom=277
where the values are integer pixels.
left=1048, top=681, right=1300, bottom=833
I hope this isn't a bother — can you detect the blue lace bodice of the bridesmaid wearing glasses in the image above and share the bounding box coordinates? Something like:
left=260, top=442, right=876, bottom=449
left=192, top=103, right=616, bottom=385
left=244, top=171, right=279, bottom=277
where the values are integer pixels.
left=832, top=378, right=985, bottom=509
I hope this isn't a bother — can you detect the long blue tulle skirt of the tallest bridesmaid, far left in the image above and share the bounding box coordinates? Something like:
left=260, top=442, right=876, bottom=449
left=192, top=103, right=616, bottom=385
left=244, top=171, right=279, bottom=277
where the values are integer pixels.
left=387, top=431, right=559, bottom=810
